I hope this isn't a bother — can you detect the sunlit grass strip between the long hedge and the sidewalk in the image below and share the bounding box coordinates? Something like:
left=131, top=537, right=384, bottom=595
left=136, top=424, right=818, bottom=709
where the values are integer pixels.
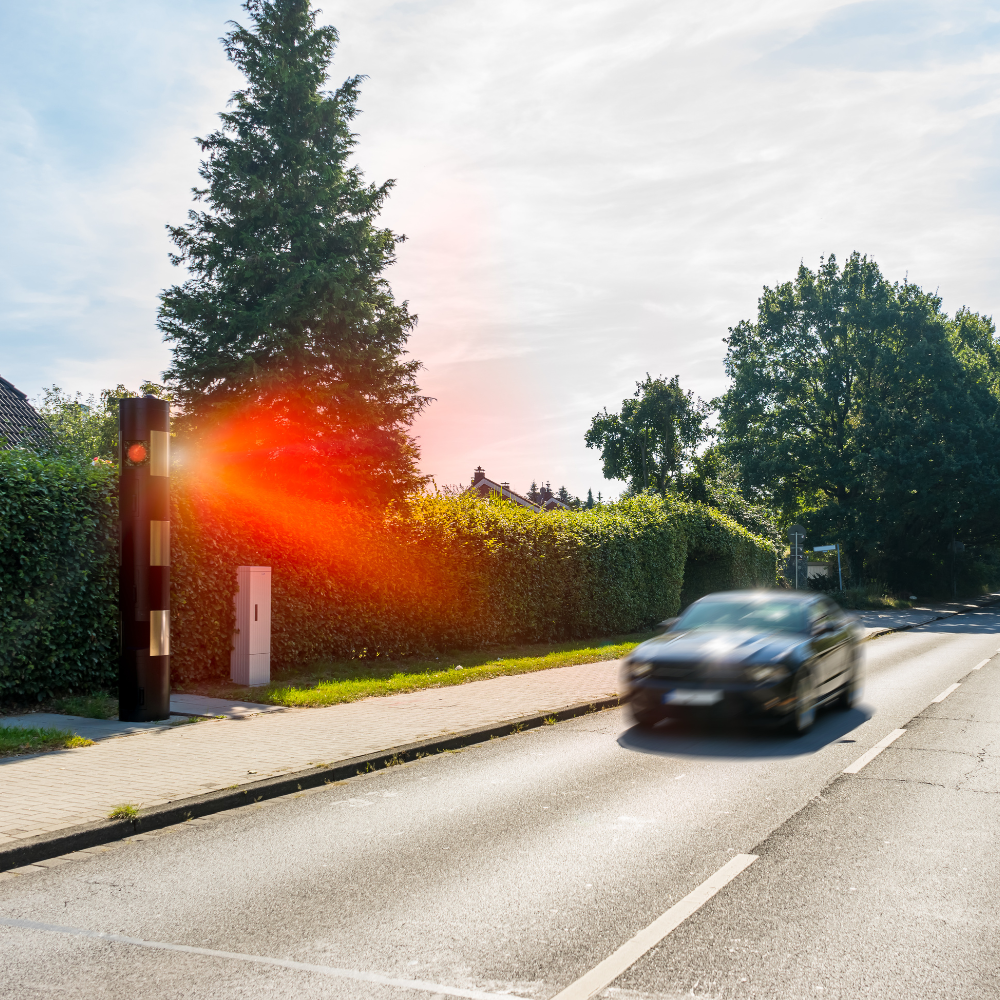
left=174, top=632, right=653, bottom=708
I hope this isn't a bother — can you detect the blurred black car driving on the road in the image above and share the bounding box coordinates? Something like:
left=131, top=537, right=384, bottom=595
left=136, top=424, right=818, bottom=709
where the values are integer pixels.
left=622, top=590, right=861, bottom=735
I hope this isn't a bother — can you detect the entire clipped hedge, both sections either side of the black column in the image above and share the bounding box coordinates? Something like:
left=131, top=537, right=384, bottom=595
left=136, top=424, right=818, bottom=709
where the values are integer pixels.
left=0, top=452, right=775, bottom=699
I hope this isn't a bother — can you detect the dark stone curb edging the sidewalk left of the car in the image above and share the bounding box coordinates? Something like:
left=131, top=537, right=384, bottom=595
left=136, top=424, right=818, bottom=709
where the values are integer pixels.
left=0, top=697, right=621, bottom=871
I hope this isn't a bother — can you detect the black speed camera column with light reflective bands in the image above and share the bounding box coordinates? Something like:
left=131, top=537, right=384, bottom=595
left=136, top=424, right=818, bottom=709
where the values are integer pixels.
left=118, top=396, right=170, bottom=722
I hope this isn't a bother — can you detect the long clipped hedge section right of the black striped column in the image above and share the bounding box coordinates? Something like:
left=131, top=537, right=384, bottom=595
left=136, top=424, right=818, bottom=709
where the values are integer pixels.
left=171, top=488, right=776, bottom=680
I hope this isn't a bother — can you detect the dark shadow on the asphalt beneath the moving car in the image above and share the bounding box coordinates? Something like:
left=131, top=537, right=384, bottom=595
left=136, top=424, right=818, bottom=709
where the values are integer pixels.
left=618, top=705, right=872, bottom=758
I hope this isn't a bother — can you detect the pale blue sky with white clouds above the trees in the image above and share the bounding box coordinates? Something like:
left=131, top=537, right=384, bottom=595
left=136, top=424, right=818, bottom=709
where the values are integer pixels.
left=0, top=0, right=1000, bottom=497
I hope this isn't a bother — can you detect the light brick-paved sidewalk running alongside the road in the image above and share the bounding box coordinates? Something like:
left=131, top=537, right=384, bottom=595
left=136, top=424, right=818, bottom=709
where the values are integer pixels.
left=0, top=595, right=1000, bottom=869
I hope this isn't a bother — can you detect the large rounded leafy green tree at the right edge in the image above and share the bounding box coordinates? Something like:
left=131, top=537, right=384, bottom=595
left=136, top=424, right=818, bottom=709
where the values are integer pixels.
left=721, top=253, right=1000, bottom=581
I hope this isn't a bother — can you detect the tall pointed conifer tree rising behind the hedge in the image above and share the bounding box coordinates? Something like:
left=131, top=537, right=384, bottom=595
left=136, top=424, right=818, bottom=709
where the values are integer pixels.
left=159, top=0, right=428, bottom=501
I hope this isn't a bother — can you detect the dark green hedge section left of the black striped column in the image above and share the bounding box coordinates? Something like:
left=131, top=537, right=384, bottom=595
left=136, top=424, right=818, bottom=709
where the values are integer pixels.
left=0, top=449, right=118, bottom=701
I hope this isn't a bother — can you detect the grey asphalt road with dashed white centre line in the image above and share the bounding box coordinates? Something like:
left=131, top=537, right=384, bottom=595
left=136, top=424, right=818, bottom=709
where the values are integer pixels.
left=0, top=609, right=1000, bottom=1000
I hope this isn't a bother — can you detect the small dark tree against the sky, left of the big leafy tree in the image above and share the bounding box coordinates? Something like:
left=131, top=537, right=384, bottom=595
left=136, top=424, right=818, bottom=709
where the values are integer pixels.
left=585, top=373, right=711, bottom=496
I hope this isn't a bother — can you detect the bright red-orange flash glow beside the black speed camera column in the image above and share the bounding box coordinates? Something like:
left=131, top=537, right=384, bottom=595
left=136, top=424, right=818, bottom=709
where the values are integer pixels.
left=175, top=396, right=483, bottom=666
